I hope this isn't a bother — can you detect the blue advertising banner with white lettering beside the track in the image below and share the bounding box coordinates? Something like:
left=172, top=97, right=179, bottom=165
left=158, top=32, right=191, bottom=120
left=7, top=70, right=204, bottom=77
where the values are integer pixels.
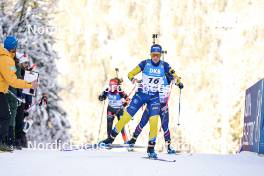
left=242, top=79, right=264, bottom=154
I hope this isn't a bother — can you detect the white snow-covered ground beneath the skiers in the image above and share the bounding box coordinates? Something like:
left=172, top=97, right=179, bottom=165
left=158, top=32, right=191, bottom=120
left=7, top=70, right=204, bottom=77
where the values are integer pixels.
left=0, top=150, right=264, bottom=176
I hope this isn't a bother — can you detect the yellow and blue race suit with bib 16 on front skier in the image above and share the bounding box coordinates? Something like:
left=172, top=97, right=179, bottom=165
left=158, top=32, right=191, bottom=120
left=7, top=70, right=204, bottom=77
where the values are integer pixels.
left=113, top=59, right=180, bottom=143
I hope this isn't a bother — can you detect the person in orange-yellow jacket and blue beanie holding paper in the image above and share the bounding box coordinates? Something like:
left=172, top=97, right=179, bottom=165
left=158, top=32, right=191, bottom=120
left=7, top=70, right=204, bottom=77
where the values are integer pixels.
left=0, top=36, right=38, bottom=151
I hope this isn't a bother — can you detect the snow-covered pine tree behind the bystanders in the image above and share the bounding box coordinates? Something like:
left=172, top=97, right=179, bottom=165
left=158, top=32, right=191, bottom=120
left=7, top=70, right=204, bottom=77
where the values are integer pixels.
left=0, top=0, right=70, bottom=143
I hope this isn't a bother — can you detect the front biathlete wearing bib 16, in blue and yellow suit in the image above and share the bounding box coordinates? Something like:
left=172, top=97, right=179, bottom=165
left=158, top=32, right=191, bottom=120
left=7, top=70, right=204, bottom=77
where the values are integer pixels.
left=100, top=44, right=183, bottom=158
